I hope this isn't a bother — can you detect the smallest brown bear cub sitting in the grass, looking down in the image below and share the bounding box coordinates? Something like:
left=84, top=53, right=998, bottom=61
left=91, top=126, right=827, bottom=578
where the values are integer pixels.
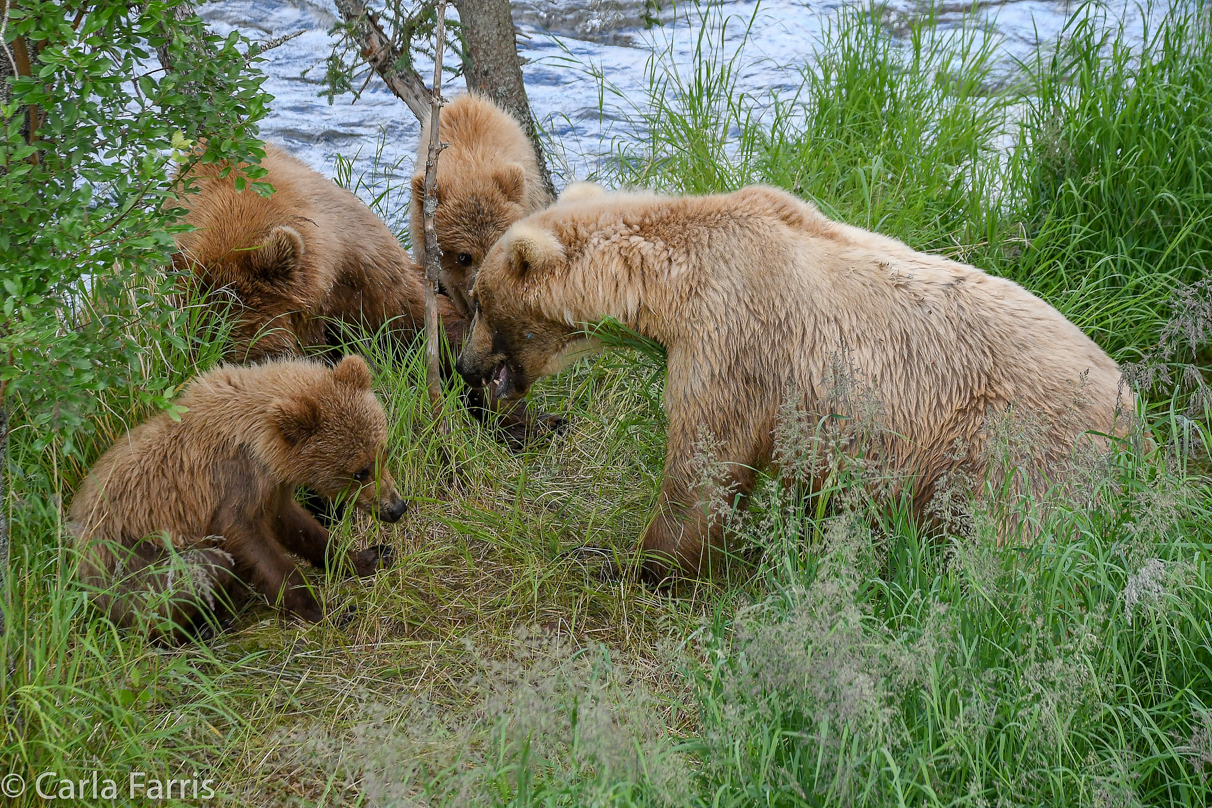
left=70, top=356, right=406, bottom=635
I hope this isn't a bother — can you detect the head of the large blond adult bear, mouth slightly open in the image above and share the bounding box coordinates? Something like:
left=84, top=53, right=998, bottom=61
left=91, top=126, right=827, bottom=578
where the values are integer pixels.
left=456, top=222, right=587, bottom=399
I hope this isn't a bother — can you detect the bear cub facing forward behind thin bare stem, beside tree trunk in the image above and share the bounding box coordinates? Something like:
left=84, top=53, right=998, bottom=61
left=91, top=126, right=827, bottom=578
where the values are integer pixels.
left=410, top=93, right=551, bottom=317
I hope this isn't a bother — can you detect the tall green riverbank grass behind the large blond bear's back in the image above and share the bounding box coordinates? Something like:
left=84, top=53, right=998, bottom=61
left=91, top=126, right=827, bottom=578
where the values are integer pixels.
left=601, top=4, right=1212, bottom=370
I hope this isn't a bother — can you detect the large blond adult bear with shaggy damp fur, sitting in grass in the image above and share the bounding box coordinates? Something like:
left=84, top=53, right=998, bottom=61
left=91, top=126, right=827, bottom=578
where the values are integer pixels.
left=457, top=187, right=1132, bottom=579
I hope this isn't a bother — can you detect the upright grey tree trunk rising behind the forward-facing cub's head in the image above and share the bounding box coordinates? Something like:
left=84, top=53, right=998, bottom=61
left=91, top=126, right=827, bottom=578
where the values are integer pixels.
left=455, top=0, right=555, bottom=199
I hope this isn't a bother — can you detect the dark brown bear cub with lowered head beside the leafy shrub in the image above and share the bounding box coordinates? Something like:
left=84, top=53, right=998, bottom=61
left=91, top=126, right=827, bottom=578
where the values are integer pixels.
left=175, top=144, right=463, bottom=362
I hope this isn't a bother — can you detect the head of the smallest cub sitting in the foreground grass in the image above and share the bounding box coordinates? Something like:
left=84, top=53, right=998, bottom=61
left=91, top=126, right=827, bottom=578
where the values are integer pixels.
left=273, top=356, right=407, bottom=522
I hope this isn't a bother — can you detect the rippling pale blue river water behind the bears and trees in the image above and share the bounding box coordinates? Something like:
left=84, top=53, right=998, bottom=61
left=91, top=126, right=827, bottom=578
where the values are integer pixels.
left=199, top=0, right=1144, bottom=196
